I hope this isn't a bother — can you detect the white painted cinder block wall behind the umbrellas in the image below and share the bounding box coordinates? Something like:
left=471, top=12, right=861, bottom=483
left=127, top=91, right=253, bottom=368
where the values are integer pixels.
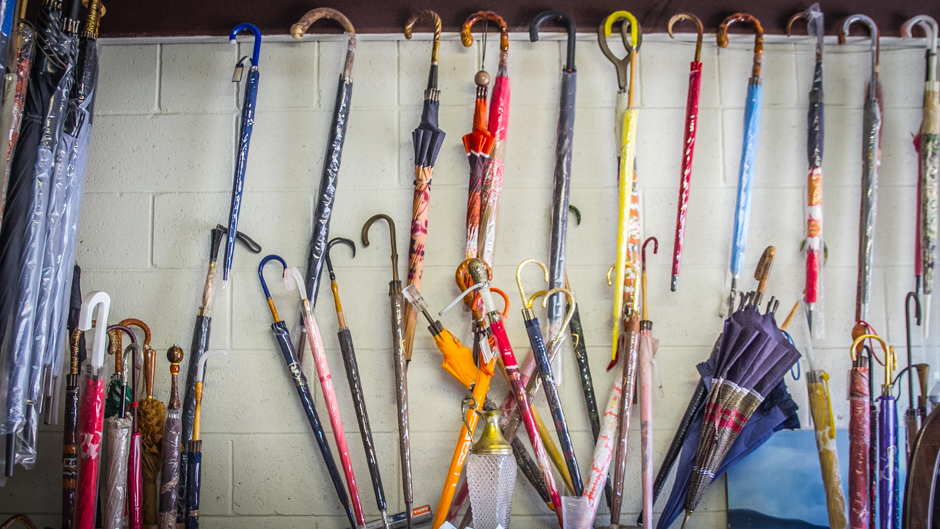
left=0, top=34, right=940, bottom=529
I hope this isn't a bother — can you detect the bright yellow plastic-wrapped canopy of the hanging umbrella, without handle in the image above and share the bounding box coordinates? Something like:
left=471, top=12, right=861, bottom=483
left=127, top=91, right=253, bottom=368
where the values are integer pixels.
left=611, top=108, right=640, bottom=359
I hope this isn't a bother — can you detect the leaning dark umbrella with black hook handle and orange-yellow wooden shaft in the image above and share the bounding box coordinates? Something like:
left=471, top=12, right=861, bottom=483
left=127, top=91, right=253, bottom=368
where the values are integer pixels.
left=326, top=237, right=389, bottom=527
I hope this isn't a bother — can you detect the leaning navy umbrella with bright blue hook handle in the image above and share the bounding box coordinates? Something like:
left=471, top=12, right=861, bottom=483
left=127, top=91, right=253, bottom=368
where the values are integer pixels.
left=258, top=255, right=357, bottom=527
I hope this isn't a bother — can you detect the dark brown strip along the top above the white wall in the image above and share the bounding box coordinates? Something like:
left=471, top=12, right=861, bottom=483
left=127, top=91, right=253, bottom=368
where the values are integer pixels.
left=47, top=0, right=940, bottom=37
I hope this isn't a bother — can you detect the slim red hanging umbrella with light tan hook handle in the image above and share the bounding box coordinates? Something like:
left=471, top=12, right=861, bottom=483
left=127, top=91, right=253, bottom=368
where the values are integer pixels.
left=666, top=13, right=705, bottom=292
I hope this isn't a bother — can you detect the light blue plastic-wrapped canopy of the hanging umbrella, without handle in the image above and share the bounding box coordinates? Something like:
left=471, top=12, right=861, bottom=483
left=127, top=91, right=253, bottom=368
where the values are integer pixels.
left=731, top=82, right=763, bottom=278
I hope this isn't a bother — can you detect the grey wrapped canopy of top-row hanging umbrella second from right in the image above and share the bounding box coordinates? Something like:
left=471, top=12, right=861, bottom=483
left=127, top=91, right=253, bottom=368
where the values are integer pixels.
left=855, top=84, right=882, bottom=321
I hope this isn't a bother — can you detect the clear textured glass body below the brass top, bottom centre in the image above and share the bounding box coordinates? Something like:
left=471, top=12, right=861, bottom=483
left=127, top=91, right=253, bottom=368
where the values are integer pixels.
left=467, top=454, right=516, bottom=529
